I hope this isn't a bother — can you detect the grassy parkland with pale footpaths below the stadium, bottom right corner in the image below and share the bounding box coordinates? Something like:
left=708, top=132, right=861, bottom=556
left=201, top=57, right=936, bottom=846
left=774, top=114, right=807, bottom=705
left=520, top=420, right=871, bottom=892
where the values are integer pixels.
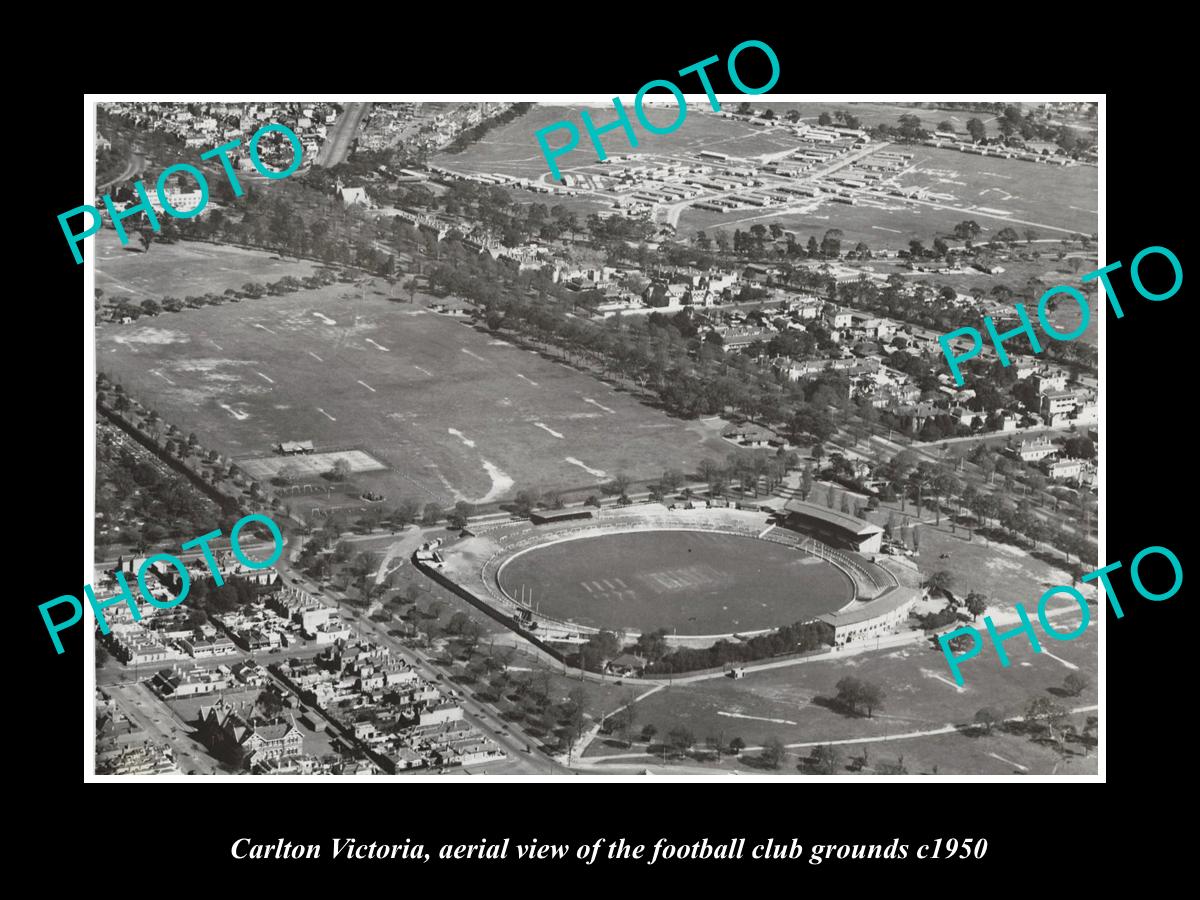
left=587, top=622, right=1097, bottom=774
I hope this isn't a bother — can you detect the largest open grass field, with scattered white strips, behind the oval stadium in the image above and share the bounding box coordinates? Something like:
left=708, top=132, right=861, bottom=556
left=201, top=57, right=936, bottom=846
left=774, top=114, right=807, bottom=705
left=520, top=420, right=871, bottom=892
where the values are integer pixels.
left=96, top=250, right=726, bottom=511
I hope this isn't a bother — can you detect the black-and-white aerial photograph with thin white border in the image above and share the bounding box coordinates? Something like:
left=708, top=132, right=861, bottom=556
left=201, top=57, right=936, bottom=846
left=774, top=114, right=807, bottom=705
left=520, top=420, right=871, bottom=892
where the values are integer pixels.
left=77, top=93, right=1104, bottom=780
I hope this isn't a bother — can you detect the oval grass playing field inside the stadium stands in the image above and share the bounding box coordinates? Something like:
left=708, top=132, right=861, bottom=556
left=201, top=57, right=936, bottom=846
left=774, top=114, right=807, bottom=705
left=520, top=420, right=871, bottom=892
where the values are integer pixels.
left=499, top=532, right=852, bottom=635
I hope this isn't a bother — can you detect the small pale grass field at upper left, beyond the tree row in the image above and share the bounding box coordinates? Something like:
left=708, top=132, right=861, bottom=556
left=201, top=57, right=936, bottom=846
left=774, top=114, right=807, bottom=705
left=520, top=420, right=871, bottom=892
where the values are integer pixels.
left=92, top=228, right=317, bottom=302
